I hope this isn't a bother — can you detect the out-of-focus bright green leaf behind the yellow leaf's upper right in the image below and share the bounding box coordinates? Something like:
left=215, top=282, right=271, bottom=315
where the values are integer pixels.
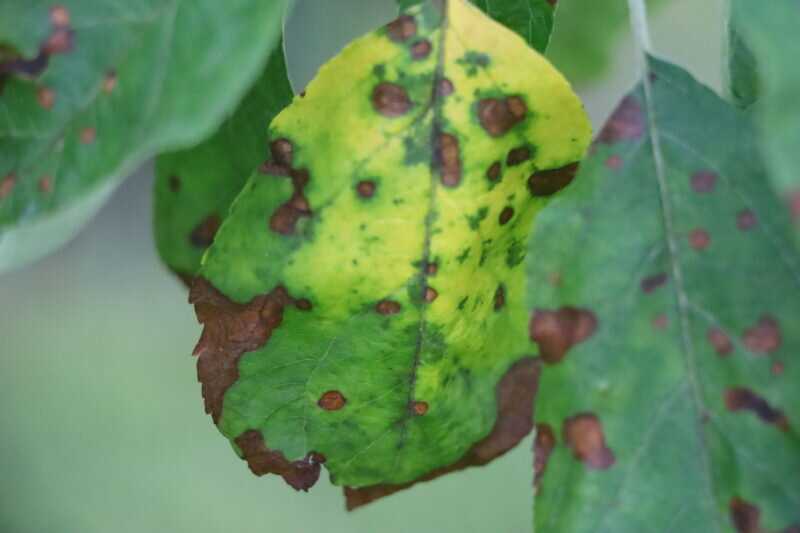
left=547, top=0, right=667, bottom=83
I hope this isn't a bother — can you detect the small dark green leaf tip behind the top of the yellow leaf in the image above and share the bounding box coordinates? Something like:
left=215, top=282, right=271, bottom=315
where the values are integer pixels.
left=397, top=0, right=556, bottom=52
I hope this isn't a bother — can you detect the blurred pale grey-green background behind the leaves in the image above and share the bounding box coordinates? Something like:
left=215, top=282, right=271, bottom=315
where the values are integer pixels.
left=0, top=0, right=723, bottom=533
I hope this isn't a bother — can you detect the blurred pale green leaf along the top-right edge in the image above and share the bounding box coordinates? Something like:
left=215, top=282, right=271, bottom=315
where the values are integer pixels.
left=732, top=0, right=800, bottom=206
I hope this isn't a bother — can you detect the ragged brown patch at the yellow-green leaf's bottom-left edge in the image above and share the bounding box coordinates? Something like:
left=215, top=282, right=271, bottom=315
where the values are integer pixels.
left=235, top=429, right=325, bottom=492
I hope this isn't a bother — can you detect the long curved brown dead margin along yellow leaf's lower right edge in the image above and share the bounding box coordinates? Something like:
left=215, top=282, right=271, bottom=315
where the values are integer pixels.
left=344, top=357, right=541, bottom=511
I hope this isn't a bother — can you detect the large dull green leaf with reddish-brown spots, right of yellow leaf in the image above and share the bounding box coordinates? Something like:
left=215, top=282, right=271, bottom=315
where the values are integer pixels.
left=527, top=58, right=800, bottom=533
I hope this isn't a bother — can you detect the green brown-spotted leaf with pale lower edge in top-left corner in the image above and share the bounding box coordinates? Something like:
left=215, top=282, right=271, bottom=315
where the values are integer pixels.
left=0, top=0, right=286, bottom=271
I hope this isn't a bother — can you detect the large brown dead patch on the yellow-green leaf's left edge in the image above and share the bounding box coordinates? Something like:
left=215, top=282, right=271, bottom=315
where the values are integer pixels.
left=189, top=277, right=292, bottom=423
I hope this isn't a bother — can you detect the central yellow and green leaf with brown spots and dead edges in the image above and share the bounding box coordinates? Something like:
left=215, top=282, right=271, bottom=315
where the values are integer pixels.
left=191, top=1, right=590, bottom=498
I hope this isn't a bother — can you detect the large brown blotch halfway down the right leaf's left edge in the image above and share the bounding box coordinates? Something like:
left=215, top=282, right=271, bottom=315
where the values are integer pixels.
left=528, top=307, right=597, bottom=364
